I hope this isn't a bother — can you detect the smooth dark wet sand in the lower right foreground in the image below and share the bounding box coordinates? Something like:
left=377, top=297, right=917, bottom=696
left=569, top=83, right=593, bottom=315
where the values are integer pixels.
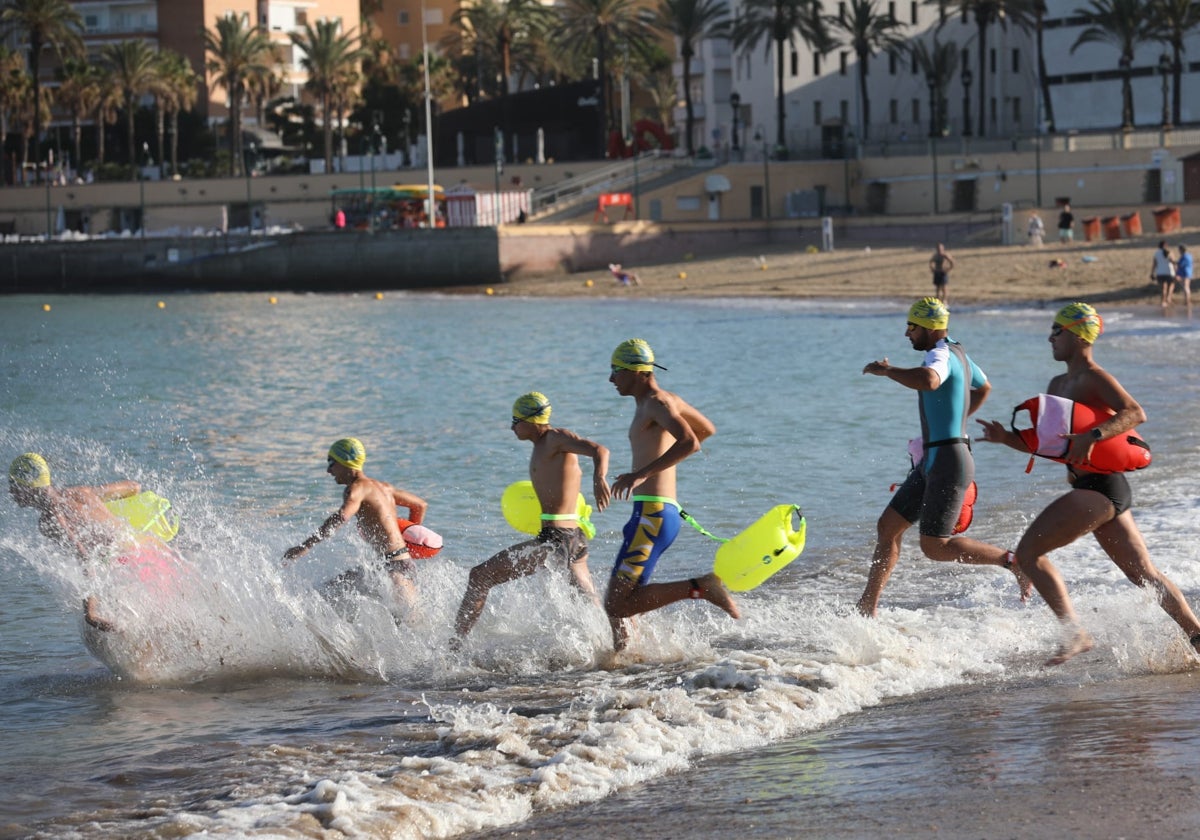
left=473, top=667, right=1200, bottom=840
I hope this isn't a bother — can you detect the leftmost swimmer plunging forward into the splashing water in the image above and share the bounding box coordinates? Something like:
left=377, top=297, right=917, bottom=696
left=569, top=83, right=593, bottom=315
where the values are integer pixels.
left=8, top=452, right=178, bottom=632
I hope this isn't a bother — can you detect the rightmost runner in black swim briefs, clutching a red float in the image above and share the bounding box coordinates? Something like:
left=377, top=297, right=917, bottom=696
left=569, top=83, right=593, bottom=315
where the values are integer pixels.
left=978, top=302, right=1200, bottom=665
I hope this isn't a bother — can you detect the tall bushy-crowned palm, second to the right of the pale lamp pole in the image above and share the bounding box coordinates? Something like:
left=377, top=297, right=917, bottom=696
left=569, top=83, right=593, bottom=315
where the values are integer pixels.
left=550, top=0, right=654, bottom=154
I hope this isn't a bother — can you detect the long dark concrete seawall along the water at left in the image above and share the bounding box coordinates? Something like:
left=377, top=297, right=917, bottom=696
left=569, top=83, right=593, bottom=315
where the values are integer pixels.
left=0, top=228, right=500, bottom=294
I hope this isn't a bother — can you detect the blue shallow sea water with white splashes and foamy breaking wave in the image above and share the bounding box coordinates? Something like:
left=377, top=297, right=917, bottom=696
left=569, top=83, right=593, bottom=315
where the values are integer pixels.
left=0, top=294, right=1200, bottom=838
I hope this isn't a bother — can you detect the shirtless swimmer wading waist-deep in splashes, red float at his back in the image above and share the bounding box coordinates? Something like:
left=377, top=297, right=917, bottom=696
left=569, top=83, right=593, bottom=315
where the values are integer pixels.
left=283, top=438, right=428, bottom=607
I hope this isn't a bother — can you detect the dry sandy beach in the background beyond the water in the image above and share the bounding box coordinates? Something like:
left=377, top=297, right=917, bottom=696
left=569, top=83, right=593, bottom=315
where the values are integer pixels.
left=461, top=229, right=1200, bottom=307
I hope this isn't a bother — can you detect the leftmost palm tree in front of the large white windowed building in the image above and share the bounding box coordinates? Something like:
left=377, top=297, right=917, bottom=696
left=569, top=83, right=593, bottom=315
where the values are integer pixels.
left=733, top=0, right=829, bottom=157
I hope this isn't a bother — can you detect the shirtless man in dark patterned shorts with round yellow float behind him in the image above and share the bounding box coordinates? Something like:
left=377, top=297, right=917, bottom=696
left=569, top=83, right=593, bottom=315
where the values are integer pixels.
left=451, top=391, right=608, bottom=649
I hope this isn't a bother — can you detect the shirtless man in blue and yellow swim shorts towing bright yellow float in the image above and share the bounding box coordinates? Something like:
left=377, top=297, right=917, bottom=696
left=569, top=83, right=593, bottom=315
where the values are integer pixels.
left=604, top=338, right=742, bottom=650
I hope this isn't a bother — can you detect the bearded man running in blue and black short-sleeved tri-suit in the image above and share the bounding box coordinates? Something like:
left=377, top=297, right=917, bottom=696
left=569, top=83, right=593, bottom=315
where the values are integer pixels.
left=858, top=298, right=1031, bottom=618
